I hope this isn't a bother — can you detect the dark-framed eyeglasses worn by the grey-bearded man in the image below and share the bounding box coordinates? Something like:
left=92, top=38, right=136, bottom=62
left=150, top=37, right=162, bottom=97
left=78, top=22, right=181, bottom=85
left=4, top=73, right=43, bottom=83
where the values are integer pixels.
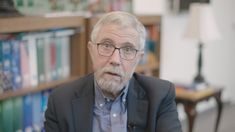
left=97, top=43, right=139, bottom=60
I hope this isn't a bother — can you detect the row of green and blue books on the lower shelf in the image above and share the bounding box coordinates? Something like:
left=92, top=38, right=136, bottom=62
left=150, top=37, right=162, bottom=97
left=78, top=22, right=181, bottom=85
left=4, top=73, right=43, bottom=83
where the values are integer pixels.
left=0, top=90, right=51, bottom=132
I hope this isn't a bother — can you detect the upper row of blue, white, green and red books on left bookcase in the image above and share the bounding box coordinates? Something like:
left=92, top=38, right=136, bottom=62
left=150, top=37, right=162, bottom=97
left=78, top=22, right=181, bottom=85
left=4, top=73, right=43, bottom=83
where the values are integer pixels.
left=0, top=29, right=75, bottom=93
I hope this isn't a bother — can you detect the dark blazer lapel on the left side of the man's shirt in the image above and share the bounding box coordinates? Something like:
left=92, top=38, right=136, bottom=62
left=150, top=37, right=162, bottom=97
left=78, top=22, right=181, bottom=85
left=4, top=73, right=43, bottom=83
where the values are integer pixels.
left=72, top=75, right=94, bottom=132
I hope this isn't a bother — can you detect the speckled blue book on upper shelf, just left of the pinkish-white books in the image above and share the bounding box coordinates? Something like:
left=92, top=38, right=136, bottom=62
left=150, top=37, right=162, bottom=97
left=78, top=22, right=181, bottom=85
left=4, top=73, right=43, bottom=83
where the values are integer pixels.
left=11, top=40, right=22, bottom=90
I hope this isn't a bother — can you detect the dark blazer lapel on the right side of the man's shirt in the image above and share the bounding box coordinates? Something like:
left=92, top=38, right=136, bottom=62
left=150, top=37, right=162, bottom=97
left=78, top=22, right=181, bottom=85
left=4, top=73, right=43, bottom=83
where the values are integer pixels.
left=127, top=78, right=148, bottom=130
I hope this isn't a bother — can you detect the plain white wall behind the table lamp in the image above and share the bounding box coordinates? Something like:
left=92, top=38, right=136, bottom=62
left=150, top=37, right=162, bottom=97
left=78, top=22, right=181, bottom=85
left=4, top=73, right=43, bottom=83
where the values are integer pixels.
left=160, top=0, right=235, bottom=101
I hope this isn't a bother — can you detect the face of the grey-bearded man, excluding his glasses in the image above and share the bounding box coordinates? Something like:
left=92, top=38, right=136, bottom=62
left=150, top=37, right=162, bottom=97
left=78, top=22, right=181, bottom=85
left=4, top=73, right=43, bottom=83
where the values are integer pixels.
left=88, top=24, right=143, bottom=94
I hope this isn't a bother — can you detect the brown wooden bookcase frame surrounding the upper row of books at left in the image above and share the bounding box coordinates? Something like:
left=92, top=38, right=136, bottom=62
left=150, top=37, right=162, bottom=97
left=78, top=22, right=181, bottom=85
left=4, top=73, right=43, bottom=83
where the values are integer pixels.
left=0, top=16, right=86, bottom=101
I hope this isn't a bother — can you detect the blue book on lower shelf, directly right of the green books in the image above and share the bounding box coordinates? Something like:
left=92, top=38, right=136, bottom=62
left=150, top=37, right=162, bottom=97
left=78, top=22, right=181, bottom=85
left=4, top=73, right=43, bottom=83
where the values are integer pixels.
left=23, top=95, right=33, bottom=132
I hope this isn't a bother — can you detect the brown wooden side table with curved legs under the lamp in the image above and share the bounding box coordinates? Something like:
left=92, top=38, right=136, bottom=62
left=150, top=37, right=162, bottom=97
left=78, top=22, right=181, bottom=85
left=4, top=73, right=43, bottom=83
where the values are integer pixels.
left=176, top=86, right=223, bottom=132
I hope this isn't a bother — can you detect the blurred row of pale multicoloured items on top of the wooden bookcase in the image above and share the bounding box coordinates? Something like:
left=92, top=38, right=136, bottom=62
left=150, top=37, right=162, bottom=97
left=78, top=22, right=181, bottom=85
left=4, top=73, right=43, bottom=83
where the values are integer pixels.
left=14, top=0, right=132, bottom=15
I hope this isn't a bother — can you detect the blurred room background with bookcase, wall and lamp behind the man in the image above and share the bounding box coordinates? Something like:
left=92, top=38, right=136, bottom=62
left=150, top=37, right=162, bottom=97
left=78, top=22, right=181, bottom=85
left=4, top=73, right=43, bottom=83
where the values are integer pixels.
left=0, top=0, right=235, bottom=132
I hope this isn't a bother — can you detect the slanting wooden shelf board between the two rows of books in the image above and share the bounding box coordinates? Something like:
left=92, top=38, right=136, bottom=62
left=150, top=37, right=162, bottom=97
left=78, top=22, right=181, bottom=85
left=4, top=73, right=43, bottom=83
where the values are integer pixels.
left=0, top=76, right=78, bottom=101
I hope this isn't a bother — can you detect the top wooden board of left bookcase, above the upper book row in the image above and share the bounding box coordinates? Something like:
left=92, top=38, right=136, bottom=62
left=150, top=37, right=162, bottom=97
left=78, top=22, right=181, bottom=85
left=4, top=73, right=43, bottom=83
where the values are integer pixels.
left=0, top=16, right=85, bottom=33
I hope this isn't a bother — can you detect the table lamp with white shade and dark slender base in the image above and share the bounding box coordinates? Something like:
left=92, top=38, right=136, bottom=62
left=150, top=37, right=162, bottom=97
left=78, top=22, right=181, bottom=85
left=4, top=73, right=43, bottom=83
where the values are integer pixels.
left=184, top=3, right=221, bottom=84
